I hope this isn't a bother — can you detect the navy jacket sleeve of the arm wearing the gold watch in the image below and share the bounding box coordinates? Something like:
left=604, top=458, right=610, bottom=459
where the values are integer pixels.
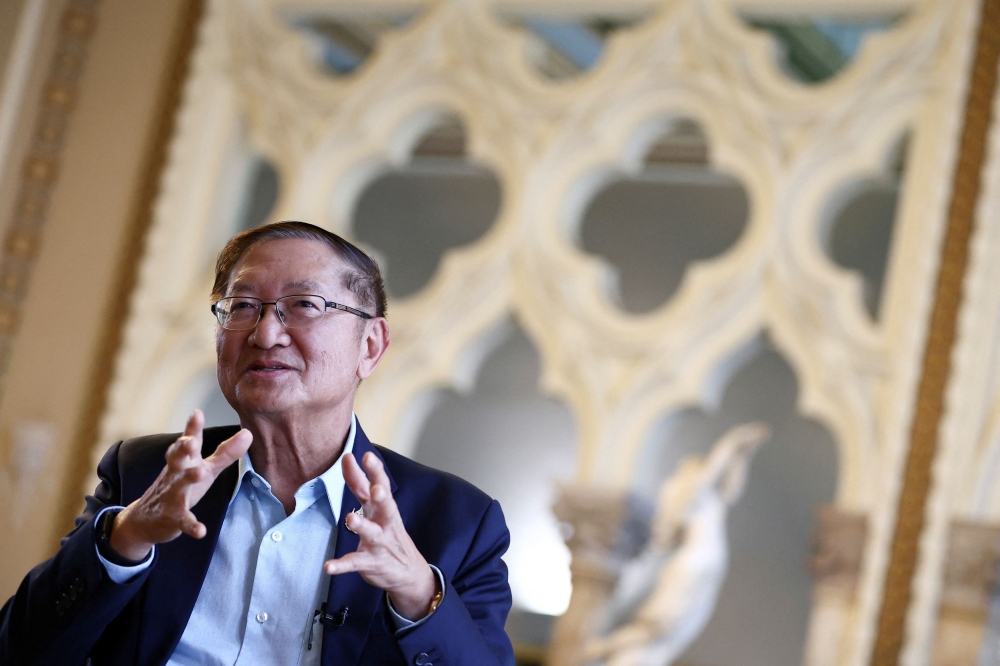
left=397, top=500, right=514, bottom=666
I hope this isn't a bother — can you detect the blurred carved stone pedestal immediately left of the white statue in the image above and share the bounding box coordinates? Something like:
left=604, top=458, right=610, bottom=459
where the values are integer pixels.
left=546, top=486, right=648, bottom=666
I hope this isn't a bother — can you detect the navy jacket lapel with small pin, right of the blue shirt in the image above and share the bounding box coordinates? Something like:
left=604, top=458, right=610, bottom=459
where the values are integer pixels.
left=323, top=424, right=396, bottom=666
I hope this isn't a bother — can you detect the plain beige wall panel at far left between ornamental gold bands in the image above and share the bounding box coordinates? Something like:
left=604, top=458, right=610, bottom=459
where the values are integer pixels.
left=0, top=0, right=186, bottom=598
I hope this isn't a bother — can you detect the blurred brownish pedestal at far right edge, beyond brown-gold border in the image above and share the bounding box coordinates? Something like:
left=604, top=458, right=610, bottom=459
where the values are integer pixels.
left=931, top=521, right=1000, bottom=666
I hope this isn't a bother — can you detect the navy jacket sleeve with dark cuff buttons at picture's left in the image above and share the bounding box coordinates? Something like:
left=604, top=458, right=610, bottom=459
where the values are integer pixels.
left=0, top=442, right=155, bottom=665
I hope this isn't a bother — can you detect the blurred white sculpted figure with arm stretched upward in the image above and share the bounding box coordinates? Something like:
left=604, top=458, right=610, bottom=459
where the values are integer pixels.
left=585, top=423, right=771, bottom=666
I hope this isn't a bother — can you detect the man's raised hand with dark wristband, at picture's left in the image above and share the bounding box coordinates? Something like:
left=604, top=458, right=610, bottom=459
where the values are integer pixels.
left=110, top=410, right=253, bottom=560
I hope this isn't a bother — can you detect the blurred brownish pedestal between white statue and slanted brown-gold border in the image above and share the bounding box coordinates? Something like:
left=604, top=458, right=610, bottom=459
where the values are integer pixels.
left=803, top=506, right=868, bottom=666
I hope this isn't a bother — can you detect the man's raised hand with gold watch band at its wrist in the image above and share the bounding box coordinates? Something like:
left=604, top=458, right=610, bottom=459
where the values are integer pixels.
left=323, top=452, right=438, bottom=620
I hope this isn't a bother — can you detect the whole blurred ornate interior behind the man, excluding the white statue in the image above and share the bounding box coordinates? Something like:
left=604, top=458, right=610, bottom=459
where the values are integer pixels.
left=0, top=0, right=1000, bottom=666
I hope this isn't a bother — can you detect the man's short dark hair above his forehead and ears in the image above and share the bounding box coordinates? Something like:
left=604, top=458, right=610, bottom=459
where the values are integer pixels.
left=212, top=221, right=386, bottom=317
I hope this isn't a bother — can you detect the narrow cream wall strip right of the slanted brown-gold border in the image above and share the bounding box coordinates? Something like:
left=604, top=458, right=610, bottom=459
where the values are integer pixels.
left=902, top=40, right=1000, bottom=666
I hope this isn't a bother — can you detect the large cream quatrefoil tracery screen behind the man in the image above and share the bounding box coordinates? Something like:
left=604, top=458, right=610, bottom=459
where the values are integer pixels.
left=95, top=0, right=980, bottom=664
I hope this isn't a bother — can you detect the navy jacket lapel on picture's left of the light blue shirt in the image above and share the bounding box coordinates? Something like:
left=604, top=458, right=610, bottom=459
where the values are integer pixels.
left=137, top=429, right=238, bottom=664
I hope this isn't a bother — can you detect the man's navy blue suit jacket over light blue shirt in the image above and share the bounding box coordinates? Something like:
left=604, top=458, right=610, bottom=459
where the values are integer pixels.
left=0, top=426, right=514, bottom=666
